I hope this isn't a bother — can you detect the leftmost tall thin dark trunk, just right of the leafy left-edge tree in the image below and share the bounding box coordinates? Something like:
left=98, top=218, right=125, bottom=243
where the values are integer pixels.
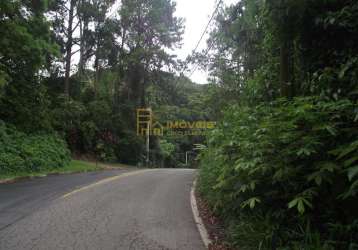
left=65, top=0, right=75, bottom=96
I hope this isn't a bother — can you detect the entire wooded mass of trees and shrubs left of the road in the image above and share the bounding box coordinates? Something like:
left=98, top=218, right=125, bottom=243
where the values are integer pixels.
left=0, top=0, right=208, bottom=176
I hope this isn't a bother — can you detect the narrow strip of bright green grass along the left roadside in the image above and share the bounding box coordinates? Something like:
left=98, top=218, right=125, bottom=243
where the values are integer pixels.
left=0, top=160, right=104, bottom=180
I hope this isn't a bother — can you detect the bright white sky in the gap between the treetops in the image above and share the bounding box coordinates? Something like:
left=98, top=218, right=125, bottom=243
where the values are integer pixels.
left=174, top=0, right=238, bottom=84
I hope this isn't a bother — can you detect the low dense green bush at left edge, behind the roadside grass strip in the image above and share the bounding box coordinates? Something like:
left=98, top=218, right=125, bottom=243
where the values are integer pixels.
left=0, top=121, right=71, bottom=174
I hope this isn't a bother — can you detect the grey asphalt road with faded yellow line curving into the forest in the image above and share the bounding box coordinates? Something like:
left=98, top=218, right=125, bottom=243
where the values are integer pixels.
left=0, top=169, right=205, bottom=250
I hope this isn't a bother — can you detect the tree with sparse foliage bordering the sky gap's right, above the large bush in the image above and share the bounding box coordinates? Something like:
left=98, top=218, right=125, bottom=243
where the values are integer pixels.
left=201, top=0, right=264, bottom=103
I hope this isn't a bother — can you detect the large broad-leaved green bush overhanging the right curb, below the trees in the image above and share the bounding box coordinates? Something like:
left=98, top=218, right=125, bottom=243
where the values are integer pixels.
left=199, top=98, right=358, bottom=249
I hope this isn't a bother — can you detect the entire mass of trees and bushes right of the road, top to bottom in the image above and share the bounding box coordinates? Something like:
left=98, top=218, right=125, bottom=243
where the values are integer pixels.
left=198, top=0, right=358, bottom=249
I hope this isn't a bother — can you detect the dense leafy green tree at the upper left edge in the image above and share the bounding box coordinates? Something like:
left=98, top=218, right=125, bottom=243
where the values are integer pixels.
left=0, top=1, right=58, bottom=130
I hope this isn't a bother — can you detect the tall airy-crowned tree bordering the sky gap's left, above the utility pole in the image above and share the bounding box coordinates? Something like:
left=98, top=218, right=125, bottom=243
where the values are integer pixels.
left=118, top=0, right=183, bottom=106
